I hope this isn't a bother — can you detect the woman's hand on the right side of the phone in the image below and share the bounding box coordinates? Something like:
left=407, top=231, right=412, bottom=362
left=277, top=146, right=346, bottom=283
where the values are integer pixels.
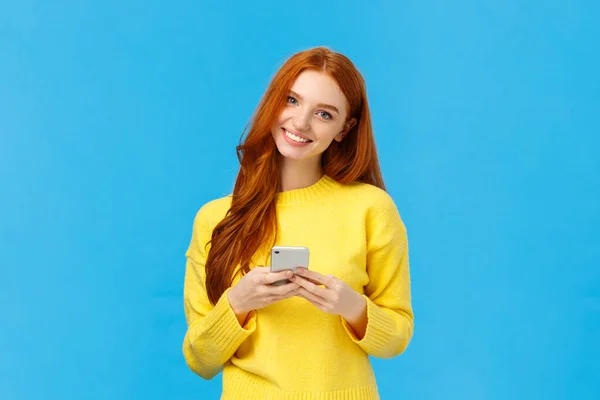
left=290, top=268, right=367, bottom=324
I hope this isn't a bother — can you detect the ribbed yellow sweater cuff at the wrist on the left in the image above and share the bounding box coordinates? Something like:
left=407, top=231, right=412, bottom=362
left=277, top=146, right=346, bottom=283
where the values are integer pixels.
left=206, top=288, right=256, bottom=353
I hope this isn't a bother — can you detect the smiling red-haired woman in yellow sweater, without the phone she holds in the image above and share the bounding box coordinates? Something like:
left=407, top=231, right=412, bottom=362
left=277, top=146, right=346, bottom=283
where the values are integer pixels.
left=183, top=47, right=413, bottom=400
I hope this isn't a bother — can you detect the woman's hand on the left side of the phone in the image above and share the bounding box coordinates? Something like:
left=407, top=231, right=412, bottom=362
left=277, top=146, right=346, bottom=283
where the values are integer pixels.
left=228, top=267, right=299, bottom=325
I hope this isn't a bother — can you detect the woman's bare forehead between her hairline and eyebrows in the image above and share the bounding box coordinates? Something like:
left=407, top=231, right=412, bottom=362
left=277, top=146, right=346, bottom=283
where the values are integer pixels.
left=292, top=71, right=346, bottom=110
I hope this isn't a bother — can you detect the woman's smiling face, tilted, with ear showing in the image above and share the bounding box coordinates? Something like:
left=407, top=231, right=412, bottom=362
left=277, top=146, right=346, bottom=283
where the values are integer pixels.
left=272, top=71, right=356, bottom=160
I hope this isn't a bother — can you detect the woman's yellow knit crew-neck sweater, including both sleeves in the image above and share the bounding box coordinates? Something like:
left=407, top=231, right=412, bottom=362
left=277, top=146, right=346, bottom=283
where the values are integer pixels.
left=183, top=175, right=413, bottom=400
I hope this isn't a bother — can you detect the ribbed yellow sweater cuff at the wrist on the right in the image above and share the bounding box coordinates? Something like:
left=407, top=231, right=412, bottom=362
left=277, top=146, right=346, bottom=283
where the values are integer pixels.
left=342, top=295, right=396, bottom=354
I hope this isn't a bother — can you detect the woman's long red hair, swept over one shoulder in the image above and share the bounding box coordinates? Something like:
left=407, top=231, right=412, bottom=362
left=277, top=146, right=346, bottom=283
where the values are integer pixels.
left=205, top=47, right=385, bottom=305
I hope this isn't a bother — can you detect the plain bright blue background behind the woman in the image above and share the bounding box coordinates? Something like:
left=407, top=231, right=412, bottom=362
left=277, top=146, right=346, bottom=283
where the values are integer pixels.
left=0, top=0, right=600, bottom=400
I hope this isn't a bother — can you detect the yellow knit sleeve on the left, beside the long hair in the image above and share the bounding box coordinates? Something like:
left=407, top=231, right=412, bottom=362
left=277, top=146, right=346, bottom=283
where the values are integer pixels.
left=183, top=207, right=256, bottom=379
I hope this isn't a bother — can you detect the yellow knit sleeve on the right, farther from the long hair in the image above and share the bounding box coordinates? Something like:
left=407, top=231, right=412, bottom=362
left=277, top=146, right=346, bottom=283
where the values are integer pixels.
left=342, top=192, right=414, bottom=358
